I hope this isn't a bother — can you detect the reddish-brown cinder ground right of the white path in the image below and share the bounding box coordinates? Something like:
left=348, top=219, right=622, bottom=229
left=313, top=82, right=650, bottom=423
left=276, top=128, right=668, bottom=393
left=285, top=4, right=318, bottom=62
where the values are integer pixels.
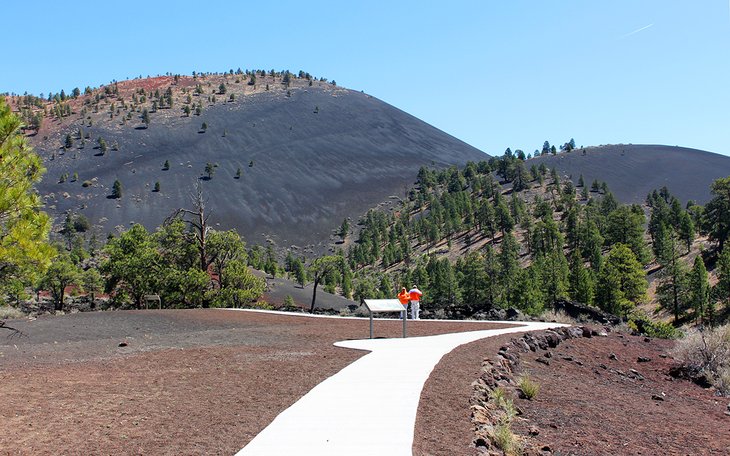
left=413, top=333, right=730, bottom=455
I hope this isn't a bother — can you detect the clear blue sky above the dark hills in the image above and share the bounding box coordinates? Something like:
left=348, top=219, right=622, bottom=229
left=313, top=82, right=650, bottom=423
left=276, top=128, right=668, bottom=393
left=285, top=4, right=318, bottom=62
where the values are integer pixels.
left=0, top=0, right=730, bottom=155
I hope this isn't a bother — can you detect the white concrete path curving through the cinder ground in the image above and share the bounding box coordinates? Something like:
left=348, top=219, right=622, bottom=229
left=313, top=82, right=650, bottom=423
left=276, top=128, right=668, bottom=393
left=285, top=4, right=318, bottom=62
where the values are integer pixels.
left=237, top=314, right=564, bottom=456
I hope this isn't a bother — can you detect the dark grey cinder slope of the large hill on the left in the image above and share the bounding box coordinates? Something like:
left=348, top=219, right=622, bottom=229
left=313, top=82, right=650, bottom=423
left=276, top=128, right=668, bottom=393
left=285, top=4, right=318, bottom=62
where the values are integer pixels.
left=38, top=86, right=487, bottom=246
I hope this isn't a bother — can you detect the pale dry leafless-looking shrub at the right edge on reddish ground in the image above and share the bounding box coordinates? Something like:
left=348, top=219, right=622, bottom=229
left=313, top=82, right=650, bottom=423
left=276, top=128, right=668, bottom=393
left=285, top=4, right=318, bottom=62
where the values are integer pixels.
left=672, top=324, right=730, bottom=395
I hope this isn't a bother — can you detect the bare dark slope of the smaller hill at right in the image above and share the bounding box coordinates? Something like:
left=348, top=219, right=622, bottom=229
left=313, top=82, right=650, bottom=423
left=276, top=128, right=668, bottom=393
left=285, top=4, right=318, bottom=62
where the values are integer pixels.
left=528, top=144, right=730, bottom=203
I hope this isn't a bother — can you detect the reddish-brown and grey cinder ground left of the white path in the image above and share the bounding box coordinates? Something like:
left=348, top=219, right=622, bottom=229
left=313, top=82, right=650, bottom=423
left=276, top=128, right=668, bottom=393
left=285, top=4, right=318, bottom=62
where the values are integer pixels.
left=0, top=309, right=510, bottom=455
